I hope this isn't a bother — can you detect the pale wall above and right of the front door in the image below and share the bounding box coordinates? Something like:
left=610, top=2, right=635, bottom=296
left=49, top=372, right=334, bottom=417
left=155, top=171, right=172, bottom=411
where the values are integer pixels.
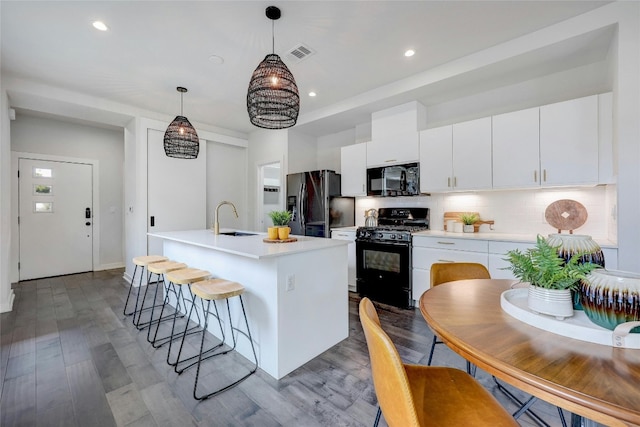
left=11, top=113, right=124, bottom=279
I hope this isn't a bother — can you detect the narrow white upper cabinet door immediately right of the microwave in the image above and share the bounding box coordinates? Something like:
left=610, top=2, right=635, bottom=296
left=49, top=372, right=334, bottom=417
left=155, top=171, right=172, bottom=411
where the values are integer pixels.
left=420, top=126, right=453, bottom=193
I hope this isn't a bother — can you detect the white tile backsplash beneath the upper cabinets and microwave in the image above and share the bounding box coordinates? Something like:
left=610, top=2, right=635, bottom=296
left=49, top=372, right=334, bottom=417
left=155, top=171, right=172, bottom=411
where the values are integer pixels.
left=356, top=185, right=618, bottom=243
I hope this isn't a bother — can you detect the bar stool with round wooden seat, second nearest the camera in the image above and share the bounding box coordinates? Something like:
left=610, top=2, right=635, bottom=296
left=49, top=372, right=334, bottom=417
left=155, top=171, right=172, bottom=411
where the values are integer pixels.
left=162, top=268, right=211, bottom=366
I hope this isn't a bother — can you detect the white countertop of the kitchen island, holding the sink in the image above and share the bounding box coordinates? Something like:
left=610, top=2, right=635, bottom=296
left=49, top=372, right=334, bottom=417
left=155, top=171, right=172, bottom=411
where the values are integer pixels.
left=148, top=229, right=349, bottom=259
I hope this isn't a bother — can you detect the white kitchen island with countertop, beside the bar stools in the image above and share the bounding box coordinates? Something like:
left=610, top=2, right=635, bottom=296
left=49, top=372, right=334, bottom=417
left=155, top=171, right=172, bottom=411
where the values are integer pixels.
left=149, top=230, right=349, bottom=379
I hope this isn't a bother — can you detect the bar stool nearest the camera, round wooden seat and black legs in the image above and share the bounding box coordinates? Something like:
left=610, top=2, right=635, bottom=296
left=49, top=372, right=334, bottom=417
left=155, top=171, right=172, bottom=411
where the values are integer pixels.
left=180, top=279, right=258, bottom=400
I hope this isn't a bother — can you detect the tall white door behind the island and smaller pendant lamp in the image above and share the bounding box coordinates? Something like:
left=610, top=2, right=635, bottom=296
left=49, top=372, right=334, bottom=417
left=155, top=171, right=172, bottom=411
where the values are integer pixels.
left=147, top=129, right=207, bottom=254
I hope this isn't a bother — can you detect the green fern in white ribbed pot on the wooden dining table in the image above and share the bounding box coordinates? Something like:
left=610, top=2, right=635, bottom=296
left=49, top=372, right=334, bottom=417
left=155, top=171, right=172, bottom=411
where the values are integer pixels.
left=505, top=236, right=600, bottom=320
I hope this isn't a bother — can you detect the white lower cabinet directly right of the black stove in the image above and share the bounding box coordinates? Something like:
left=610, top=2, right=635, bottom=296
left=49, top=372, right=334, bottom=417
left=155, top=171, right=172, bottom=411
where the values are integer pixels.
left=412, top=236, right=489, bottom=304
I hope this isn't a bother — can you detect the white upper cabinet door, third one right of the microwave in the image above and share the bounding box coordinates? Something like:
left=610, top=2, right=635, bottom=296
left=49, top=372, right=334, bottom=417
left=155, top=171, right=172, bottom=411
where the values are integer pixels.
left=492, top=107, right=541, bottom=188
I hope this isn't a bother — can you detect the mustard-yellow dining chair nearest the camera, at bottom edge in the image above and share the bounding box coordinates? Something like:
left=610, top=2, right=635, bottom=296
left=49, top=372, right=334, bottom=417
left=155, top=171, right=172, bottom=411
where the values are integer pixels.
left=360, top=298, right=518, bottom=427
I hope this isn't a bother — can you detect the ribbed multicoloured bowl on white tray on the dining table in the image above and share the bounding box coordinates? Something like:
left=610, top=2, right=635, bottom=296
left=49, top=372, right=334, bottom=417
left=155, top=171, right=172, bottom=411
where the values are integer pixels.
left=580, top=268, right=640, bottom=333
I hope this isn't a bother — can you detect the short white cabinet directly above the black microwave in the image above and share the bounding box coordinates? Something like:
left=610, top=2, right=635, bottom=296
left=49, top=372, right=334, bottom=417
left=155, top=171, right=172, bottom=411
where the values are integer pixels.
left=367, top=130, right=419, bottom=167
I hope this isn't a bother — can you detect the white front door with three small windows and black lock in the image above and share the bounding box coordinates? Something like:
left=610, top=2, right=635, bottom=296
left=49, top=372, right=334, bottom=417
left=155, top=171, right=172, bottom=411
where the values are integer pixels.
left=18, top=158, right=93, bottom=280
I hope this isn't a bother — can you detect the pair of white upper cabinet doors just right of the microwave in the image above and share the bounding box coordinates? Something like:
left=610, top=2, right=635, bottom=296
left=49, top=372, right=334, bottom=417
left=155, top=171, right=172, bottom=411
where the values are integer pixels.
left=420, top=117, right=491, bottom=193
